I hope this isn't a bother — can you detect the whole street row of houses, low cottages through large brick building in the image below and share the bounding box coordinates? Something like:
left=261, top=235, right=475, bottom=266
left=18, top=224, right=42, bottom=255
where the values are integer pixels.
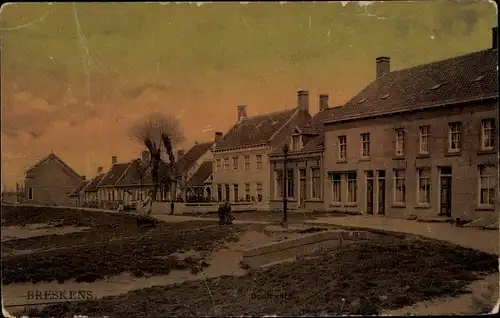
left=26, top=27, right=500, bottom=219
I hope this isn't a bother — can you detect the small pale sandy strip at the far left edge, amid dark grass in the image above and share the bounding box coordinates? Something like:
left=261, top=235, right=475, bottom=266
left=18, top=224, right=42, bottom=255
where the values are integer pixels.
left=1, top=223, right=90, bottom=242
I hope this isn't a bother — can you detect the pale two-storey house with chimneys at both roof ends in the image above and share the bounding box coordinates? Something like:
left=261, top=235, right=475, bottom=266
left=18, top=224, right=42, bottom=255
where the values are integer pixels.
left=213, top=91, right=311, bottom=204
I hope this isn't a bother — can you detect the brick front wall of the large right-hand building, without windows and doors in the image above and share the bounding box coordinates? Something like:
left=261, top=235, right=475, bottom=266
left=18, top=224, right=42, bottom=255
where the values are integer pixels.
left=323, top=102, right=500, bottom=219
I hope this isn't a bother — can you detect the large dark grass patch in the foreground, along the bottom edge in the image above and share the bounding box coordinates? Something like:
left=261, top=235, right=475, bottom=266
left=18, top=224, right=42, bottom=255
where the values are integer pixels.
left=14, top=236, right=498, bottom=317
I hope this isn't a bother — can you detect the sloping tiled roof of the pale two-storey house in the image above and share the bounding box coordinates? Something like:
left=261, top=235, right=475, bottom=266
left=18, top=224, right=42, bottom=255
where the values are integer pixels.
left=215, top=108, right=298, bottom=149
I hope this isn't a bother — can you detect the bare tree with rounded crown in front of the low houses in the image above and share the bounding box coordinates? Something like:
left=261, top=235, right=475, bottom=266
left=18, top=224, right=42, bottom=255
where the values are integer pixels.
left=132, top=113, right=184, bottom=200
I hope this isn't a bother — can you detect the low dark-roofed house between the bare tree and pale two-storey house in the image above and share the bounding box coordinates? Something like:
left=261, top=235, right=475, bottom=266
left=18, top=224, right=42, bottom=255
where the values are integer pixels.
left=177, top=132, right=222, bottom=201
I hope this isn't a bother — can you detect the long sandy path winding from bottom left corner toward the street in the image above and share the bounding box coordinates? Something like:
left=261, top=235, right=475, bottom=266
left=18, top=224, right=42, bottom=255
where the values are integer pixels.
left=2, top=231, right=302, bottom=312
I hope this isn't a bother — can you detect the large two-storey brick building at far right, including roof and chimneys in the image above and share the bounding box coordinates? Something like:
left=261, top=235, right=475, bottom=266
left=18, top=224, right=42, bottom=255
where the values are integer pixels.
left=324, top=28, right=500, bottom=219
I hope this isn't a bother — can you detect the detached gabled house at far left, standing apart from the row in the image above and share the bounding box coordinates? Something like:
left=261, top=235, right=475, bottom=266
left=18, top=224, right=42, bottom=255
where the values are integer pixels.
left=25, top=153, right=82, bottom=206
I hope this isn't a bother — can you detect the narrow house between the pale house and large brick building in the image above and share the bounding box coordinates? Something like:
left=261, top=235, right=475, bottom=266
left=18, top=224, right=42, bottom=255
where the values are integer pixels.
left=269, top=94, right=346, bottom=214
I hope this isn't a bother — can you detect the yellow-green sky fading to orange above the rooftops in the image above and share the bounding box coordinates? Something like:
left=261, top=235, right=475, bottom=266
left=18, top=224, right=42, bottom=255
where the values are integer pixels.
left=0, top=0, right=497, bottom=188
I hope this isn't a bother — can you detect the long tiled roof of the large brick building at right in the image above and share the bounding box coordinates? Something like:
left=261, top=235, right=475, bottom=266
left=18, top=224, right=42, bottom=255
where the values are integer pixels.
left=324, top=49, right=498, bottom=121
